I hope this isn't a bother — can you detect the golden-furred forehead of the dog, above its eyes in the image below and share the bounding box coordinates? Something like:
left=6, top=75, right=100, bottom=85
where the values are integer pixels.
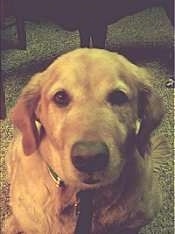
left=44, top=49, right=139, bottom=96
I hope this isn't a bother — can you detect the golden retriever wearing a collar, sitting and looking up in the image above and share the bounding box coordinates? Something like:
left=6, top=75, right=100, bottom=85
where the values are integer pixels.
left=5, top=48, right=167, bottom=234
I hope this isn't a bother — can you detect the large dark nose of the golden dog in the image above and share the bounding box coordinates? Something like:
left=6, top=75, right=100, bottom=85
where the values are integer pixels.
left=71, top=141, right=109, bottom=173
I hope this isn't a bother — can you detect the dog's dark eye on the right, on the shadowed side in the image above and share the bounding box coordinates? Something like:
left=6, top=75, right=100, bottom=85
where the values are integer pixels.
left=107, top=90, right=128, bottom=106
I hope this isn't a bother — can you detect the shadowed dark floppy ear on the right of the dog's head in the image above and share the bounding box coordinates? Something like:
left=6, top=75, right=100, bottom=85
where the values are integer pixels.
left=137, top=72, right=164, bottom=156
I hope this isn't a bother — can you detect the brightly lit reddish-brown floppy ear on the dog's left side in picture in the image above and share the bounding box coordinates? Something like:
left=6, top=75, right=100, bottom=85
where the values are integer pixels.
left=10, top=73, right=43, bottom=155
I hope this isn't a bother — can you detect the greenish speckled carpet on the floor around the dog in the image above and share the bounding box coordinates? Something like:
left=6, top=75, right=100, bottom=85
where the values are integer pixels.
left=0, top=8, right=174, bottom=234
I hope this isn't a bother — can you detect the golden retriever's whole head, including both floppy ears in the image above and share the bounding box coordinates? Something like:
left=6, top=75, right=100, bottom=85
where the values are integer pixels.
left=13, top=49, right=162, bottom=188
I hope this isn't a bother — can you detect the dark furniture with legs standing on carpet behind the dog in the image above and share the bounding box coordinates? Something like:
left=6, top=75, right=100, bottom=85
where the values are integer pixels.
left=2, top=0, right=174, bottom=49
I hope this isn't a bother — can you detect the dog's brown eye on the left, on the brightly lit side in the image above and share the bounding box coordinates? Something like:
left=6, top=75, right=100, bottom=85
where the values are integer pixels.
left=53, top=90, right=70, bottom=107
